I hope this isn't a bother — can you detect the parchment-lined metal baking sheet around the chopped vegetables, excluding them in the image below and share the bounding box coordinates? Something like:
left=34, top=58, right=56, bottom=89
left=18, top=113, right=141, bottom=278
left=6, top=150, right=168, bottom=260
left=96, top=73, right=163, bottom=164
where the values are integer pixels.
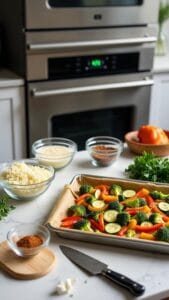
left=46, top=174, right=169, bottom=254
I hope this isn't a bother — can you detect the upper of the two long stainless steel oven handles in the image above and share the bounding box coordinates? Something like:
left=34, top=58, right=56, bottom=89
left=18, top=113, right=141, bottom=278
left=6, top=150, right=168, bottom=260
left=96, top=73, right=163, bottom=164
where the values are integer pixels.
left=27, top=36, right=157, bottom=51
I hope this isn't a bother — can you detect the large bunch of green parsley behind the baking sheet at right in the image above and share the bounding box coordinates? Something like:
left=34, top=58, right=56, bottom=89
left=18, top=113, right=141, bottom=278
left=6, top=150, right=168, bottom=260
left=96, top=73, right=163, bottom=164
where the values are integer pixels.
left=125, top=152, right=169, bottom=183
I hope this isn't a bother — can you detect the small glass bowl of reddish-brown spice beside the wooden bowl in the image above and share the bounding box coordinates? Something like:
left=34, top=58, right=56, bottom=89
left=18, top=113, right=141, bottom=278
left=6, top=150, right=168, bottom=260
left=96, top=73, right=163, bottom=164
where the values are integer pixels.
left=86, top=136, right=123, bottom=167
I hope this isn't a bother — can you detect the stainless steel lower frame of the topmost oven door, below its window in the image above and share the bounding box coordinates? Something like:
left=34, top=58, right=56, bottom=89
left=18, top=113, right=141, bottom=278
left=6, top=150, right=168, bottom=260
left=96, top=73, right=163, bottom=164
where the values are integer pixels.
left=25, top=0, right=159, bottom=29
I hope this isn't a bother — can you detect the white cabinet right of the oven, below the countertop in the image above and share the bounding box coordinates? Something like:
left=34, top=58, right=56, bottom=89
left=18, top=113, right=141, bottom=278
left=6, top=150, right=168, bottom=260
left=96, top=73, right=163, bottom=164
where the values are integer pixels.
left=149, top=55, right=169, bottom=129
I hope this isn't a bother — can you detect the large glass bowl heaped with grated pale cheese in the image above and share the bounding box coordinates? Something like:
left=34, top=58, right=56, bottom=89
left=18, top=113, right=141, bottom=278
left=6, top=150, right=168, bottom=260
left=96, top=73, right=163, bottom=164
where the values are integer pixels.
left=0, top=159, right=55, bottom=200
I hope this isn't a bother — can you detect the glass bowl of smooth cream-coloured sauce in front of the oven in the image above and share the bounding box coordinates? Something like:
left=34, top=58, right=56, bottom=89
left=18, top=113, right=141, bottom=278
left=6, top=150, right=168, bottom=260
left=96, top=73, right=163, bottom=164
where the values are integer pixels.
left=32, top=138, right=77, bottom=170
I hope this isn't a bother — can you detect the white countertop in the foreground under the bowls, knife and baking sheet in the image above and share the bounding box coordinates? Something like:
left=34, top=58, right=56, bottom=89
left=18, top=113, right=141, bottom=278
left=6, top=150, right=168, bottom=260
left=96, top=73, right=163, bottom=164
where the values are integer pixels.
left=0, top=150, right=169, bottom=300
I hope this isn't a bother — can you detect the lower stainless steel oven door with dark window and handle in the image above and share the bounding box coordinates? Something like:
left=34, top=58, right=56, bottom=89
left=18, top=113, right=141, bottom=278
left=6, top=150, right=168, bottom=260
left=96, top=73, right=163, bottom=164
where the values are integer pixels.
left=27, top=73, right=153, bottom=150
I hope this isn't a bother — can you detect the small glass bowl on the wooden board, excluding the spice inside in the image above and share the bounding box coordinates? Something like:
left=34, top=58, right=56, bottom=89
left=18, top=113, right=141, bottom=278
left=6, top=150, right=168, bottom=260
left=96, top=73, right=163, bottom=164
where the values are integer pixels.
left=7, top=223, right=50, bottom=257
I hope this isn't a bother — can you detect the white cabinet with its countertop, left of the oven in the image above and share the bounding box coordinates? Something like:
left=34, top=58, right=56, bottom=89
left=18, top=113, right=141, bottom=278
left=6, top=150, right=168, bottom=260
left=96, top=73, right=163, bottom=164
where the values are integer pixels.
left=0, top=70, right=26, bottom=162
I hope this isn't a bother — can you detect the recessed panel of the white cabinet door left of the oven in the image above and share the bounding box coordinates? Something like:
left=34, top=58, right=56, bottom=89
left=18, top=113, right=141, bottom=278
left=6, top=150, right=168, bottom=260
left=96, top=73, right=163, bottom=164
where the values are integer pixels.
left=0, top=97, right=15, bottom=162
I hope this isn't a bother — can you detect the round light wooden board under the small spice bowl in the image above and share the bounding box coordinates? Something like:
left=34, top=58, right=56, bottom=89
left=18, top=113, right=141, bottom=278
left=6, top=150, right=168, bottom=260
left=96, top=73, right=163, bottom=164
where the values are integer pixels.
left=0, top=241, right=56, bottom=279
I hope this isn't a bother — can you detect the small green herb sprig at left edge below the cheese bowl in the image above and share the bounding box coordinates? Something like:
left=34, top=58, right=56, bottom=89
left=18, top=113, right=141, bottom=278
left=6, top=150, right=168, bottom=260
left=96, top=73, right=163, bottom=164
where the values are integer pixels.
left=0, top=192, right=15, bottom=221
